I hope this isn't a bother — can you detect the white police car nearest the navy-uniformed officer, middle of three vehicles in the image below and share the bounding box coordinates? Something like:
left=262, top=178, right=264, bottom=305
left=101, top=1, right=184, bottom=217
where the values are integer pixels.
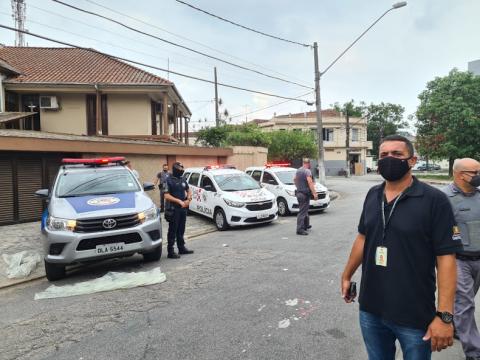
left=184, top=165, right=278, bottom=230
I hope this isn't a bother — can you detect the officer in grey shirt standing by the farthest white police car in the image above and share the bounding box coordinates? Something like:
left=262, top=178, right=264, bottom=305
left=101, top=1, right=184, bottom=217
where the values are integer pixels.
left=294, top=159, right=318, bottom=235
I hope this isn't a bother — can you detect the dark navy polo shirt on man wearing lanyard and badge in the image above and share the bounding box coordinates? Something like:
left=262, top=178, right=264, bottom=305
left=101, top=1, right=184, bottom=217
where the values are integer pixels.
left=358, top=178, right=462, bottom=330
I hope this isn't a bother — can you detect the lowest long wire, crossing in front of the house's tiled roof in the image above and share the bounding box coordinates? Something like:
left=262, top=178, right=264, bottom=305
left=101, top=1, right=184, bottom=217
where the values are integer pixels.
left=0, top=24, right=314, bottom=103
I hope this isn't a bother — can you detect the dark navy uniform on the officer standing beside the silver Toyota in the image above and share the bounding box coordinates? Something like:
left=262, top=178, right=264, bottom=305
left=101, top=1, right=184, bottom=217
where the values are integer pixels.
left=164, top=175, right=190, bottom=255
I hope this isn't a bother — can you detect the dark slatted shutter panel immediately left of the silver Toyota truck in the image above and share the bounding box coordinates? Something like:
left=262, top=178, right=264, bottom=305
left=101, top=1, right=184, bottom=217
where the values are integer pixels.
left=17, top=158, right=43, bottom=221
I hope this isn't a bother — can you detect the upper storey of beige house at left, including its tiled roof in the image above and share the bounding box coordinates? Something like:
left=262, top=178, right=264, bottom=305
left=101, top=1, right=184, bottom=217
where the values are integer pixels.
left=0, top=46, right=191, bottom=143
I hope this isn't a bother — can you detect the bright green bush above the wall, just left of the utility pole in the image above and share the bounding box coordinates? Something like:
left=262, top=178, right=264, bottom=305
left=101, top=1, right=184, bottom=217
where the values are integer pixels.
left=268, top=131, right=317, bottom=160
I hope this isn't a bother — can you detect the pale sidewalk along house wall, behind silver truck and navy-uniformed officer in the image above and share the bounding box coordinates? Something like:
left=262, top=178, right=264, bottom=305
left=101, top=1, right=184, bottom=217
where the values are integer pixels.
left=0, top=214, right=216, bottom=289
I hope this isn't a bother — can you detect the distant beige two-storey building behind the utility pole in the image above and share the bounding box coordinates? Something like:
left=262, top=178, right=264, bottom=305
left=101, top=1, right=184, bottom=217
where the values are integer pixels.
left=253, top=110, right=372, bottom=175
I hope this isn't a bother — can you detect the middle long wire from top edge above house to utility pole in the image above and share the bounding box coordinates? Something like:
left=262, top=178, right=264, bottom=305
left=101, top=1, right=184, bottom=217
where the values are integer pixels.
left=52, top=0, right=312, bottom=89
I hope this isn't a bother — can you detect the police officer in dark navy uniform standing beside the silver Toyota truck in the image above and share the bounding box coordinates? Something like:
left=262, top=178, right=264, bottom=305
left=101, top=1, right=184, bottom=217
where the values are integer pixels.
left=164, top=162, right=193, bottom=259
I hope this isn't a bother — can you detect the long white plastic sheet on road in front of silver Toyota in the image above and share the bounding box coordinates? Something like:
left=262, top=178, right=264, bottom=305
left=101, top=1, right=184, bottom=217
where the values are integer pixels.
left=35, top=267, right=167, bottom=300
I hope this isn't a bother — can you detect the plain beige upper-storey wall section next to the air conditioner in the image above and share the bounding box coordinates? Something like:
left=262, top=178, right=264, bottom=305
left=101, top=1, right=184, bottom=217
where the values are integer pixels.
left=40, top=94, right=87, bottom=135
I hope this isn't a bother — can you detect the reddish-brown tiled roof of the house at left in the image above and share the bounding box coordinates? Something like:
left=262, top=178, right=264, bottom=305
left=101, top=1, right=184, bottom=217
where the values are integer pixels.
left=0, top=46, right=172, bottom=85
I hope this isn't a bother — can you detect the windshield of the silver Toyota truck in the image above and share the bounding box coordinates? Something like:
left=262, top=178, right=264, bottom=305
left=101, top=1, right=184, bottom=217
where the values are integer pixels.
left=56, top=169, right=140, bottom=197
